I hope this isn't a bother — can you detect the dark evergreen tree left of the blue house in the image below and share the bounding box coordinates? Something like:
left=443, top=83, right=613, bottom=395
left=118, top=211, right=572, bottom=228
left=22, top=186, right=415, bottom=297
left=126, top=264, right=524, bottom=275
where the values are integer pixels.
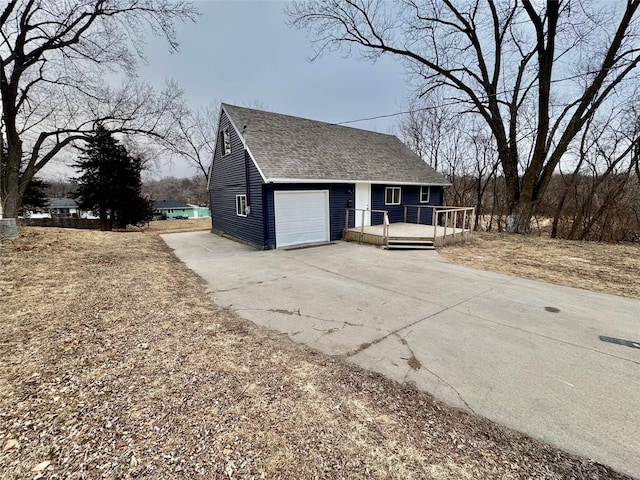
left=73, top=125, right=153, bottom=230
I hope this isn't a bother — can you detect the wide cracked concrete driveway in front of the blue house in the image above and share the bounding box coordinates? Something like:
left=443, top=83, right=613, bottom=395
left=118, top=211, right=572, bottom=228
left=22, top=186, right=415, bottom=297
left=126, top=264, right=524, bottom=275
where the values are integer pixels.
left=163, top=232, right=640, bottom=478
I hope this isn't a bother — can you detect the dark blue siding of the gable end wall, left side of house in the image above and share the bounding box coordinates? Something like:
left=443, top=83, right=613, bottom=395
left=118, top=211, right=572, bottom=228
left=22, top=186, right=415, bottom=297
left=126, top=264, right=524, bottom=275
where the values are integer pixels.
left=209, top=113, right=264, bottom=247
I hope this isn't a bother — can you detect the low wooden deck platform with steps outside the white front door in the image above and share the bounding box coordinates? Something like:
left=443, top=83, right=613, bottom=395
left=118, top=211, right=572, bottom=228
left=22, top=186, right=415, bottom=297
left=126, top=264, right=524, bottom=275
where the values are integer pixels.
left=343, top=223, right=471, bottom=247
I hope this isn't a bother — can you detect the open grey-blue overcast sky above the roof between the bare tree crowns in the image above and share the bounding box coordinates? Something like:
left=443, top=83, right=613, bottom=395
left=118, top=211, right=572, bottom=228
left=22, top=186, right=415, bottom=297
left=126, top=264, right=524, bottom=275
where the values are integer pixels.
left=140, top=0, right=406, bottom=177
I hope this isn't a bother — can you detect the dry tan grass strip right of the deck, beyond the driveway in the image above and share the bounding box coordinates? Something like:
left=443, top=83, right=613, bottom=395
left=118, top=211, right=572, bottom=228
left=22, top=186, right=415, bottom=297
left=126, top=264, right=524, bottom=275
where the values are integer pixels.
left=439, top=233, right=640, bottom=299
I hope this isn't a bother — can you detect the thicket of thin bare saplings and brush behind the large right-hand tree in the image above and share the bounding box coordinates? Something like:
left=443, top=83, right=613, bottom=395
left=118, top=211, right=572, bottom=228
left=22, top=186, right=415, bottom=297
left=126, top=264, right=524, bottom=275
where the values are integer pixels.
left=398, top=91, right=640, bottom=242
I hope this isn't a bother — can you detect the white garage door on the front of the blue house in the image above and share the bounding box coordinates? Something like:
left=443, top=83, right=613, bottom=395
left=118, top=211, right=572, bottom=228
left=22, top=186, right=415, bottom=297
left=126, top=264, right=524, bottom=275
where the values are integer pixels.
left=273, top=190, right=329, bottom=248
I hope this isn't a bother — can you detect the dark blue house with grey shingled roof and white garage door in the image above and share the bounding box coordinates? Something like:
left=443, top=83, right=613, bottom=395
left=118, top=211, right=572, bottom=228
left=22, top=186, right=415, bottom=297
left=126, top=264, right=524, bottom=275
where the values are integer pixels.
left=209, top=104, right=449, bottom=248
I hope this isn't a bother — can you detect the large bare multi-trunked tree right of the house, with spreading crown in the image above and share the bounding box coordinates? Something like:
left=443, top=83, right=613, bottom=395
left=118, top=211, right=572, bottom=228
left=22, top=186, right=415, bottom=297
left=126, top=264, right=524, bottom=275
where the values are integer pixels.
left=287, top=0, right=640, bottom=233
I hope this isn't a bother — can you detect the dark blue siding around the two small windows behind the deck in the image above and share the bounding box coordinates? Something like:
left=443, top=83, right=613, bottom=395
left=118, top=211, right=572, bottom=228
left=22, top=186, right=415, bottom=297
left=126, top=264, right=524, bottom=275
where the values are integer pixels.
left=371, top=185, right=443, bottom=225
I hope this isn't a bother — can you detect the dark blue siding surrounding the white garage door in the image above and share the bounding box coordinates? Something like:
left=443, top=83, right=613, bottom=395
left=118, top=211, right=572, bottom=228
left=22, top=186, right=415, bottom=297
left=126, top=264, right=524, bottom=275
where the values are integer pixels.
left=264, top=183, right=355, bottom=248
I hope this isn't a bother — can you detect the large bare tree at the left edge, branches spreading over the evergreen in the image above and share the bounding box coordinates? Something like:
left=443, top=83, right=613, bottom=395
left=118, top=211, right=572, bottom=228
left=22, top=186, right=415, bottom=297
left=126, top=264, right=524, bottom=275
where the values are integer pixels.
left=0, top=0, right=197, bottom=217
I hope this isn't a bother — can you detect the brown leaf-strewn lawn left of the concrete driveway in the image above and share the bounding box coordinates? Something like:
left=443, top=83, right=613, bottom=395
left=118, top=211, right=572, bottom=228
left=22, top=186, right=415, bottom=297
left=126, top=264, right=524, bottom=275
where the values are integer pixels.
left=0, top=227, right=627, bottom=479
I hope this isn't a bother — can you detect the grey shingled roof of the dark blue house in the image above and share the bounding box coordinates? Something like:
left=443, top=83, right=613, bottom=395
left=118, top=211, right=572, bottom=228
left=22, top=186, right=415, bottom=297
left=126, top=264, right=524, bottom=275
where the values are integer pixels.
left=222, top=104, right=450, bottom=185
